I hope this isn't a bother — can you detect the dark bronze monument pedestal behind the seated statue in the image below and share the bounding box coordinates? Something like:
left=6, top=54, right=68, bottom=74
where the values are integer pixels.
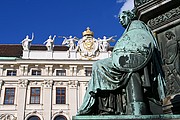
left=135, top=0, right=180, bottom=114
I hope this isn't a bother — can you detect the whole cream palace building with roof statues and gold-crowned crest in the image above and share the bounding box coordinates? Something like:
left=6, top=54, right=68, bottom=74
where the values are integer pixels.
left=0, top=28, right=113, bottom=120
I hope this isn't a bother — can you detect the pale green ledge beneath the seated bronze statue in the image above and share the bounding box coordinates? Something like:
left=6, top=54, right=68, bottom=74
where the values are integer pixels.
left=72, top=114, right=180, bottom=120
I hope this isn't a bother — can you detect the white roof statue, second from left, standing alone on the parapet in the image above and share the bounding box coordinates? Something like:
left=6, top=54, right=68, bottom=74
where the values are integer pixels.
left=43, top=35, right=56, bottom=51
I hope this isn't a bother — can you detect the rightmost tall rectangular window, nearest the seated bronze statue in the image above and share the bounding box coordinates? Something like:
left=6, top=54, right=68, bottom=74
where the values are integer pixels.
left=56, top=87, right=66, bottom=104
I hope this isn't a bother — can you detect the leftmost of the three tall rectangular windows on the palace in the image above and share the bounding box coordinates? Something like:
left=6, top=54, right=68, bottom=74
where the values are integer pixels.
left=4, top=88, right=15, bottom=105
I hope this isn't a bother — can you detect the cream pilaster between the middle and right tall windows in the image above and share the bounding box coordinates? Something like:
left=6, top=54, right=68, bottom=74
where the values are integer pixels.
left=43, top=80, right=53, bottom=120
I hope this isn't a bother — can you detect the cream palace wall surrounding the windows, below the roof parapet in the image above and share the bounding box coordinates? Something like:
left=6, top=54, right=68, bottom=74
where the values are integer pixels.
left=0, top=51, right=109, bottom=120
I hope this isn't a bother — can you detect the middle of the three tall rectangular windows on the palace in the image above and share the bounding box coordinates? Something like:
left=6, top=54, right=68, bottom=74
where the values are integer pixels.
left=30, top=87, right=40, bottom=104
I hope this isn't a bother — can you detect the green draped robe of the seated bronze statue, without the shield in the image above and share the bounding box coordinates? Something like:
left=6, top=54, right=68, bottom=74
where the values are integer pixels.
left=77, top=20, right=165, bottom=115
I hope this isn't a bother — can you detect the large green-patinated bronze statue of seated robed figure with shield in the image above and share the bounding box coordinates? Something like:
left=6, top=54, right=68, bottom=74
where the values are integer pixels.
left=77, top=11, right=165, bottom=115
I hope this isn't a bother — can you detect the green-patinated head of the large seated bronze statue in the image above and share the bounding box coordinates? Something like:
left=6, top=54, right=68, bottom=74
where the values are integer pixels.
left=119, top=10, right=135, bottom=28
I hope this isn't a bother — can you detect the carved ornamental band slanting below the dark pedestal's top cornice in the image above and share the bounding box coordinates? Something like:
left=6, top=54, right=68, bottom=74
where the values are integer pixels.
left=147, top=6, right=180, bottom=27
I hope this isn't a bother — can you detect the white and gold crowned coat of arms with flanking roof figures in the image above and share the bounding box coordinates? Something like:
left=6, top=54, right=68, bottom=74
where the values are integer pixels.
left=59, top=27, right=115, bottom=60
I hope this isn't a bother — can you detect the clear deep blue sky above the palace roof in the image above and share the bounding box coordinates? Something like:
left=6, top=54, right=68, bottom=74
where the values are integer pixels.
left=0, top=0, right=134, bottom=45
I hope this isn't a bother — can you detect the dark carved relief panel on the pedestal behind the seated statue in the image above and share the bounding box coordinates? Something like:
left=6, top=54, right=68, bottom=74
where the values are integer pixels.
left=157, top=25, right=180, bottom=95
